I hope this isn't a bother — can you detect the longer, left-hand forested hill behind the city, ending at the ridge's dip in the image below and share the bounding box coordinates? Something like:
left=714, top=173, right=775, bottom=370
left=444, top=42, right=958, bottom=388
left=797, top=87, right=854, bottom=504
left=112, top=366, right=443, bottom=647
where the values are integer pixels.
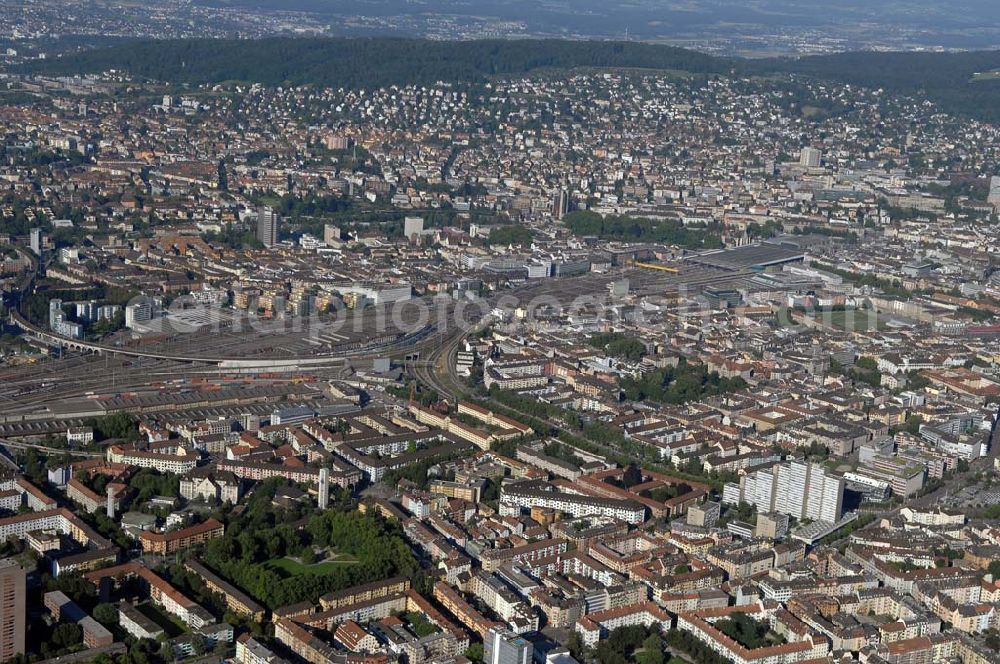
left=11, top=38, right=730, bottom=88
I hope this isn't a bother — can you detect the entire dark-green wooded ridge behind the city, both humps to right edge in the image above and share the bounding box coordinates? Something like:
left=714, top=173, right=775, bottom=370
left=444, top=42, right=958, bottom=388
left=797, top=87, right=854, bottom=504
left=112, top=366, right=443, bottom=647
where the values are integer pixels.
left=21, top=38, right=1000, bottom=122
